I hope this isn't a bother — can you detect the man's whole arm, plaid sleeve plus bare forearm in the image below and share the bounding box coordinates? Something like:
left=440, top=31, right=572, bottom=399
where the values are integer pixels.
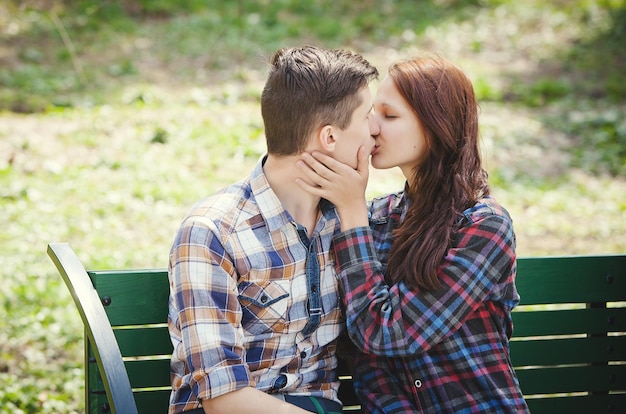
left=170, top=220, right=307, bottom=414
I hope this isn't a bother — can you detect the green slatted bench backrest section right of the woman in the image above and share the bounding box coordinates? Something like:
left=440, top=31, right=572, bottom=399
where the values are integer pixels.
left=511, top=255, right=626, bottom=413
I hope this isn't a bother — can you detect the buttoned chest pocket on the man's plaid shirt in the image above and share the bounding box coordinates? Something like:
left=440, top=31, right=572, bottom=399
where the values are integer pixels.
left=237, top=281, right=289, bottom=335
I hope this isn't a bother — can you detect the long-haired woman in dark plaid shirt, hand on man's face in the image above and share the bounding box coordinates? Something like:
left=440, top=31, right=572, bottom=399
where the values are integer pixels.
left=298, top=56, right=528, bottom=413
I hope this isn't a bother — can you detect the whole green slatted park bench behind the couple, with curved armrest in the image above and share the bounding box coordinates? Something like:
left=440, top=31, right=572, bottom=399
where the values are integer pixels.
left=48, top=243, right=626, bottom=414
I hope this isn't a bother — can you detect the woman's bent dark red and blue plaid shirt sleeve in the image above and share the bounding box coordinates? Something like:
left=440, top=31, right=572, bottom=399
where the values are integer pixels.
left=334, top=214, right=515, bottom=356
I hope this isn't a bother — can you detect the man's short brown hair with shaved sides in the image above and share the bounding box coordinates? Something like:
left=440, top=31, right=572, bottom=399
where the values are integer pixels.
left=261, top=46, right=378, bottom=155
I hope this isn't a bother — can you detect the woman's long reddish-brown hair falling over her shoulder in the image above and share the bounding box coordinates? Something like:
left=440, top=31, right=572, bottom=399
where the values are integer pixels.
left=387, top=56, right=489, bottom=291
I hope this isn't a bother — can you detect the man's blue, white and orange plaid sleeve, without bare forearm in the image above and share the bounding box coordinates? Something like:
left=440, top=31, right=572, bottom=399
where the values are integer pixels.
left=170, top=218, right=254, bottom=399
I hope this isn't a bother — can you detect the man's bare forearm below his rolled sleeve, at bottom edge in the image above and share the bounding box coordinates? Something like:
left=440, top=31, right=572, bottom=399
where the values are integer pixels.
left=202, top=387, right=309, bottom=414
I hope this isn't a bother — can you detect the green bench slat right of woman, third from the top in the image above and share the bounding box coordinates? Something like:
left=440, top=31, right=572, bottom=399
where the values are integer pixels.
left=510, top=336, right=626, bottom=367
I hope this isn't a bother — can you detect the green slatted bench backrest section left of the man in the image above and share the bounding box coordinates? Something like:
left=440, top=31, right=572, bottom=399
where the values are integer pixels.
left=85, top=269, right=172, bottom=413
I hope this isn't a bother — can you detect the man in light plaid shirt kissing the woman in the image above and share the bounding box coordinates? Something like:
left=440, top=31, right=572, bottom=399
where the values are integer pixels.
left=169, top=46, right=378, bottom=414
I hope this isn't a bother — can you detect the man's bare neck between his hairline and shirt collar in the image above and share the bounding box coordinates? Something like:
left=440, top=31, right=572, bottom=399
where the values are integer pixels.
left=263, top=154, right=320, bottom=236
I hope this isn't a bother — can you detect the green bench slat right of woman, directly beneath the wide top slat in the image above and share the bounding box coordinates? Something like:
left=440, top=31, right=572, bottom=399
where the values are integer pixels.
left=513, top=308, right=626, bottom=338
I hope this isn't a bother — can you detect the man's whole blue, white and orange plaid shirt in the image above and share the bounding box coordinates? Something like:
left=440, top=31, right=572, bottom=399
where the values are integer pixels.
left=169, top=160, right=344, bottom=413
